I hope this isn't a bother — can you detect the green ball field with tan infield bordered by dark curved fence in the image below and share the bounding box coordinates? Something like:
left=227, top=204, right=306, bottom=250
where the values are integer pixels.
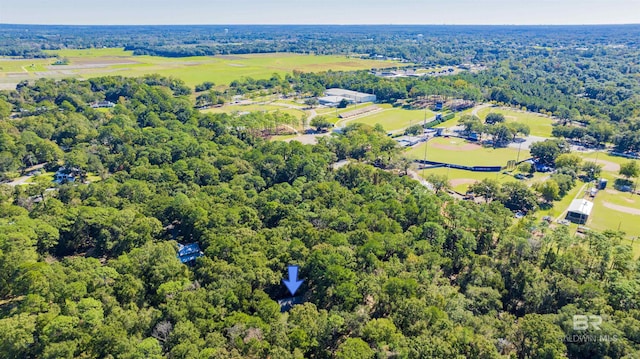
left=405, top=137, right=529, bottom=166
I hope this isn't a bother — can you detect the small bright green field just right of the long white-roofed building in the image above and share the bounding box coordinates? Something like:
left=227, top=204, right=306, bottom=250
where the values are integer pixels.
left=338, top=105, right=434, bottom=131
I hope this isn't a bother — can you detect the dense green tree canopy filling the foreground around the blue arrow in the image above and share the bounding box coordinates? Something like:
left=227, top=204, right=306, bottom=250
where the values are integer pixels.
left=0, top=71, right=640, bottom=358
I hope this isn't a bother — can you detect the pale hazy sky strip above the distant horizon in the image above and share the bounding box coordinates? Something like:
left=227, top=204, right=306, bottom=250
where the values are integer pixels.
left=0, top=0, right=640, bottom=25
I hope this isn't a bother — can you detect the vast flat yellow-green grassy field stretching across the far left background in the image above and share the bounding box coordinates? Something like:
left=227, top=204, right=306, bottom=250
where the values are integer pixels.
left=0, top=48, right=396, bottom=86
